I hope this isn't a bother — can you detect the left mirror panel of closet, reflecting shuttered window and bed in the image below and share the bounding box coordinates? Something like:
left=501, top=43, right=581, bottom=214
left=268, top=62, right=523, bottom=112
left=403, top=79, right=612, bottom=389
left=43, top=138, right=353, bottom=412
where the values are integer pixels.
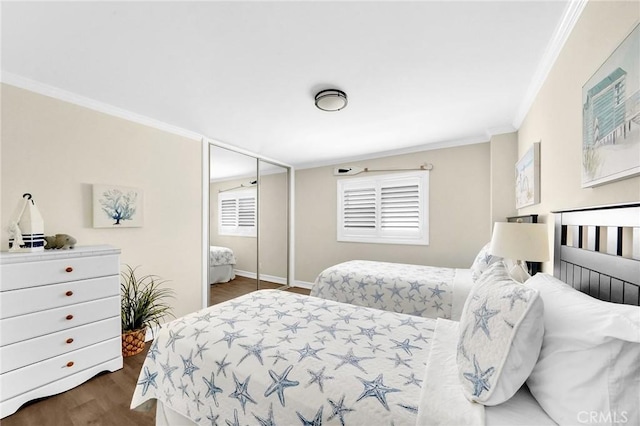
left=208, top=145, right=258, bottom=305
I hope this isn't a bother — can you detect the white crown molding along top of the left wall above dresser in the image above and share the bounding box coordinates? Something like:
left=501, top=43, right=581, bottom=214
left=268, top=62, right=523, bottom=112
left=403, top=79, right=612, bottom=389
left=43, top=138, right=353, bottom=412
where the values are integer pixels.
left=0, top=71, right=202, bottom=141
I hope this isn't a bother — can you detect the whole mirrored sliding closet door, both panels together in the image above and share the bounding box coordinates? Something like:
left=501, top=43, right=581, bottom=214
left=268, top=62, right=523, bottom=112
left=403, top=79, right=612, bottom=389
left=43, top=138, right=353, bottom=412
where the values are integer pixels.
left=206, top=144, right=290, bottom=305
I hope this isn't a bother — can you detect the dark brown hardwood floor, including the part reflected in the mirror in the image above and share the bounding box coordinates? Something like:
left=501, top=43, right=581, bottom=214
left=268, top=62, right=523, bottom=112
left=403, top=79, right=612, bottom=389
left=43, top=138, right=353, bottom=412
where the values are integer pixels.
left=0, top=277, right=309, bottom=426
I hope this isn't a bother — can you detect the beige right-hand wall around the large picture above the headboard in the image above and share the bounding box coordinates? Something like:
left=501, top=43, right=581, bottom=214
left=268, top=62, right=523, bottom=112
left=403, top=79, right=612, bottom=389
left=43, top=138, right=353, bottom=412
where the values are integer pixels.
left=518, top=1, right=640, bottom=222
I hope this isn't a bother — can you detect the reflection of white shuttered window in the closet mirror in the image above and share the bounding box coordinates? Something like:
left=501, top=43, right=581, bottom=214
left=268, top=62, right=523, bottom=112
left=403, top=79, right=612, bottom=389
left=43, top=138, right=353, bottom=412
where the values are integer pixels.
left=218, top=188, right=257, bottom=237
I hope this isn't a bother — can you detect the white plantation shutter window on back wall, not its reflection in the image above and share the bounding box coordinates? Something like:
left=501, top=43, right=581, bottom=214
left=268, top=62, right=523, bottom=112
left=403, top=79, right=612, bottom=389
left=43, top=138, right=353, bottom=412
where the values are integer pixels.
left=338, top=171, right=429, bottom=245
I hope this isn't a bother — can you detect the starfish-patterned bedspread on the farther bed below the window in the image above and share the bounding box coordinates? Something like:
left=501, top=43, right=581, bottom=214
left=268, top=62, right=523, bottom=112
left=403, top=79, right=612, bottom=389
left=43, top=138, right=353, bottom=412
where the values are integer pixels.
left=311, top=260, right=456, bottom=319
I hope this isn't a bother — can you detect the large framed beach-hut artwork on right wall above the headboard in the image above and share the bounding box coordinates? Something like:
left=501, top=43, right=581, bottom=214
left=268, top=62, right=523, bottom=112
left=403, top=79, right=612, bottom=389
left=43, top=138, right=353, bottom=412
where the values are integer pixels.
left=582, top=25, right=640, bottom=188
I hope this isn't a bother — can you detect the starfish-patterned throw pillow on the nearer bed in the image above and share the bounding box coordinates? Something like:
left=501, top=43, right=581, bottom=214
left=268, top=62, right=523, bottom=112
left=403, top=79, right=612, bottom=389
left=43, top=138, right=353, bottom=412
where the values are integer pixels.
left=457, top=262, right=544, bottom=405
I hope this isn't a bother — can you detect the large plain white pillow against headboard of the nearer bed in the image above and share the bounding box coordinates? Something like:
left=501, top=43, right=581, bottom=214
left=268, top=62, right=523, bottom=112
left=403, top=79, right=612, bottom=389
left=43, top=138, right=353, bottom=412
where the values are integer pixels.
left=525, top=273, right=640, bottom=425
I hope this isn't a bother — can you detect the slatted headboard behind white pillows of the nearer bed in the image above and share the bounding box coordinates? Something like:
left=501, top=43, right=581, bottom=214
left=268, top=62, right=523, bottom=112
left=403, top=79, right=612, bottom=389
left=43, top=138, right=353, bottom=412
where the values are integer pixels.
left=552, top=203, right=640, bottom=306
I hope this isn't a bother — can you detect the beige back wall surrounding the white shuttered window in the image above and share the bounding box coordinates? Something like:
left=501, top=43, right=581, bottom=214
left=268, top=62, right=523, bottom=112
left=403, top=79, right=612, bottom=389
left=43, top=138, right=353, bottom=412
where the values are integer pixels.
left=295, top=143, right=491, bottom=282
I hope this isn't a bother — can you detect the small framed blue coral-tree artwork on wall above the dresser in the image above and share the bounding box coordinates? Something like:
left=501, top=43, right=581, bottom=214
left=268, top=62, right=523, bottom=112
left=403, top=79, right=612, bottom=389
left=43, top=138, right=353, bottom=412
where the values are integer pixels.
left=93, top=185, right=143, bottom=228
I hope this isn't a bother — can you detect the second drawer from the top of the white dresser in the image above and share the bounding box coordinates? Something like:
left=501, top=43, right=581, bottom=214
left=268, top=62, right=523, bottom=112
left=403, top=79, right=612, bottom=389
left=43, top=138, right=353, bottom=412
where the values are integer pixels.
left=0, top=276, right=120, bottom=318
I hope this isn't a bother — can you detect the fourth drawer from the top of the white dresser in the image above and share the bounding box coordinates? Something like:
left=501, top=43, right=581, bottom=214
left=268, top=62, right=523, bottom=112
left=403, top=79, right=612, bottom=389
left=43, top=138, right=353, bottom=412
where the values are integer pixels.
left=0, top=317, right=122, bottom=374
